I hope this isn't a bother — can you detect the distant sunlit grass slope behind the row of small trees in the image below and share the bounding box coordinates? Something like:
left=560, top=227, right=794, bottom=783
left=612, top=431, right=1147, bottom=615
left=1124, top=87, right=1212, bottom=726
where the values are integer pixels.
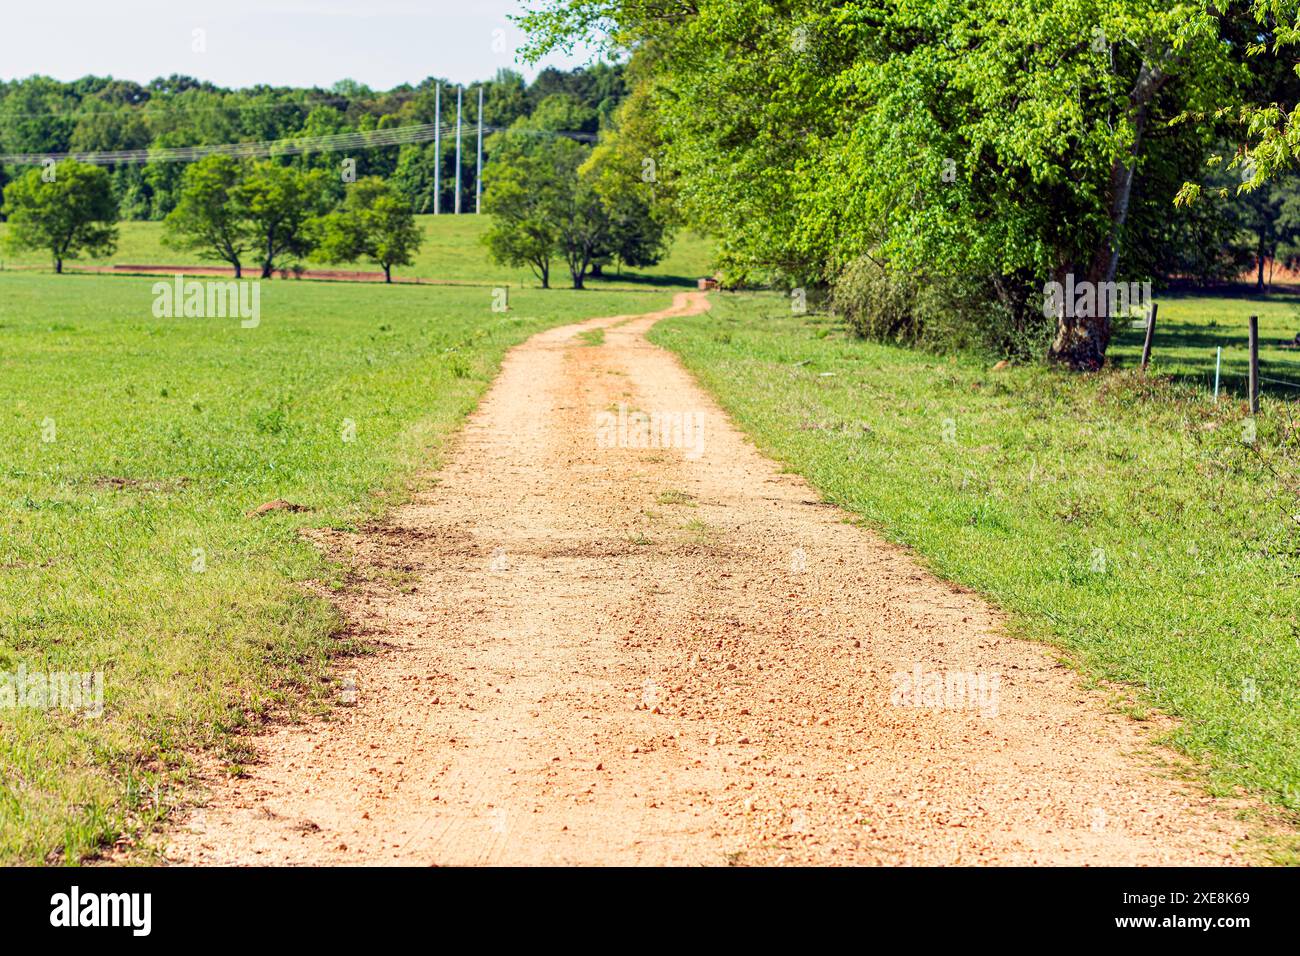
left=0, top=216, right=710, bottom=289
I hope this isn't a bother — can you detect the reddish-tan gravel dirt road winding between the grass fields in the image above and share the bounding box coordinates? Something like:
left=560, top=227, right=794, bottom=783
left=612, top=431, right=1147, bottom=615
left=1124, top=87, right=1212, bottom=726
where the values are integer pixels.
left=168, top=294, right=1244, bottom=864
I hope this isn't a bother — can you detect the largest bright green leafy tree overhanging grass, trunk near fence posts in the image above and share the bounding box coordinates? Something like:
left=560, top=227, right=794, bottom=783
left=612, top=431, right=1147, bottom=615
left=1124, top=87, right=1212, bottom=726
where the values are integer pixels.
left=523, top=0, right=1242, bottom=369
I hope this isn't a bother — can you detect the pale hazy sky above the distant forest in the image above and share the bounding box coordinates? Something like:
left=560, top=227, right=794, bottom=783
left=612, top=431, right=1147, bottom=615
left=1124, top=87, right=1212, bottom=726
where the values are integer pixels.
left=0, top=0, right=605, bottom=90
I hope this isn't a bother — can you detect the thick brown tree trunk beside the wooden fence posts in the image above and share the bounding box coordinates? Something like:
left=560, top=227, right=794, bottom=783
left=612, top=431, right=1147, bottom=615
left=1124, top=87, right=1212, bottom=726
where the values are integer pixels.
left=1048, top=61, right=1166, bottom=372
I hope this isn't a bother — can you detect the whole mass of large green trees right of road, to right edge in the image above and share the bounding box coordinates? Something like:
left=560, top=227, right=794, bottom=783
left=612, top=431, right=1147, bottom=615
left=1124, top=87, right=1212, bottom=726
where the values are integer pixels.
left=524, top=0, right=1300, bottom=369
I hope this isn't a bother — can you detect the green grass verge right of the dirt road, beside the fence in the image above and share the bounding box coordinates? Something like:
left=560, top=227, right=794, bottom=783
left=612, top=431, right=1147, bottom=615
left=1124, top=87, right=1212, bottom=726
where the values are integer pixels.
left=651, top=295, right=1300, bottom=853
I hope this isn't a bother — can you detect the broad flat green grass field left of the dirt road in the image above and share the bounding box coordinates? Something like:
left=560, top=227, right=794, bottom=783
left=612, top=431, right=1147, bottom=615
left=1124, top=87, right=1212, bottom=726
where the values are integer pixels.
left=0, top=265, right=666, bottom=864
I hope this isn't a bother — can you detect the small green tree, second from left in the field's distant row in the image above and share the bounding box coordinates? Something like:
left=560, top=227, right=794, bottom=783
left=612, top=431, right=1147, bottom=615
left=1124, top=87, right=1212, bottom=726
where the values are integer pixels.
left=163, top=155, right=254, bottom=278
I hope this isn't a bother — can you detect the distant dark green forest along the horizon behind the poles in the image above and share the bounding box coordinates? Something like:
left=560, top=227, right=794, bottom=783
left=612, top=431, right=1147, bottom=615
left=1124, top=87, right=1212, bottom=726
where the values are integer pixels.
left=0, top=64, right=627, bottom=220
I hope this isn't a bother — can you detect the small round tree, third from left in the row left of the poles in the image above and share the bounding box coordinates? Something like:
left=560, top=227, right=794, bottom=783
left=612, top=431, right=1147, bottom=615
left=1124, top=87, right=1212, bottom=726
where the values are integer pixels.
left=231, top=160, right=328, bottom=278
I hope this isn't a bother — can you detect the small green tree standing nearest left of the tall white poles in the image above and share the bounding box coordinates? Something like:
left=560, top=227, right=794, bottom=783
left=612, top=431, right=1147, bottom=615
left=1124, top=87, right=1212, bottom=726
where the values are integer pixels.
left=313, top=176, right=424, bottom=282
